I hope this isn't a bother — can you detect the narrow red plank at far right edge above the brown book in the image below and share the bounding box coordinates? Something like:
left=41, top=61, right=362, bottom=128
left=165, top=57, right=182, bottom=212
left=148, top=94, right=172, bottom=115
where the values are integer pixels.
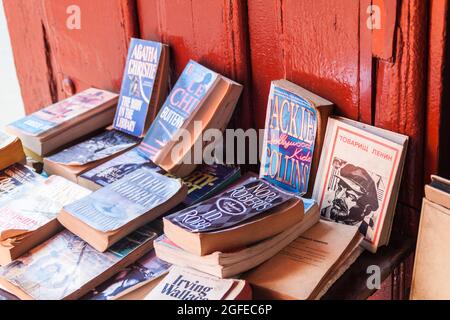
left=424, top=0, right=450, bottom=182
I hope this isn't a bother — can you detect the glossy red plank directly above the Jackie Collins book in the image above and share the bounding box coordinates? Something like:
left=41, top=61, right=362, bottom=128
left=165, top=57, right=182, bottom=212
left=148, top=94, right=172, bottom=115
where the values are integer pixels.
left=248, top=0, right=365, bottom=127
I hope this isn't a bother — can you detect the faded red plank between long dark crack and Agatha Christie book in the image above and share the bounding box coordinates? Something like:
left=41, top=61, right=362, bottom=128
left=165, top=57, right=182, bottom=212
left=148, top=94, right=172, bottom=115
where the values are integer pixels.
left=43, top=0, right=138, bottom=91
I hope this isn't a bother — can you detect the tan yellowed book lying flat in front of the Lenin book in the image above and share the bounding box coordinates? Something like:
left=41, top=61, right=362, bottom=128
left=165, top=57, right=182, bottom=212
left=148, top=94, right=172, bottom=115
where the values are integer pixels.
left=244, top=221, right=360, bottom=300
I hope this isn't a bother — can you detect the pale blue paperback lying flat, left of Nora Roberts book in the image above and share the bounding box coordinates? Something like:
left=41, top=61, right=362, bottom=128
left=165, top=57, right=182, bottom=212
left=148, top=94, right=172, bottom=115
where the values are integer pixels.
left=58, top=168, right=186, bottom=251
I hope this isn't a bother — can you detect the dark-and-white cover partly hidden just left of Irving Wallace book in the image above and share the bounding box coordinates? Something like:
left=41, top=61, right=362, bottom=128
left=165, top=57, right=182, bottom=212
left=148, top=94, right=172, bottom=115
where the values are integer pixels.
left=84, top=250, right=171, bottom=300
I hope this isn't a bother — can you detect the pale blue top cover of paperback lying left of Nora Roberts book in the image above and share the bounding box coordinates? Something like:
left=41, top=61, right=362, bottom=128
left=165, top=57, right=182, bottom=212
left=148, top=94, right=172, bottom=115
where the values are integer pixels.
left=64, top=168, right=181, bottom=232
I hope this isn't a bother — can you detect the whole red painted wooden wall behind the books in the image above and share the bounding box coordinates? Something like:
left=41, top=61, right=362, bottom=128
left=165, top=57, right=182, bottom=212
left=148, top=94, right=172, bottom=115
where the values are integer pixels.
left=4, top=0, right=450, bottom=298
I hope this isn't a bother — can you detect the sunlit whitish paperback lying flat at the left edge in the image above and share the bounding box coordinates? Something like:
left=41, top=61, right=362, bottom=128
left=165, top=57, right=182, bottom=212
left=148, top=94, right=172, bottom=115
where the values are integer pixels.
left=0, top=176, right=90, bottom=265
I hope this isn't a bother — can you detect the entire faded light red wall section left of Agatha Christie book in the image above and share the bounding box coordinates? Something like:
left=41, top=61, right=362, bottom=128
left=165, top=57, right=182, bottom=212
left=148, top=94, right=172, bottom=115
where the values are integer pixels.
left=4, top=0, right=138, bottom=113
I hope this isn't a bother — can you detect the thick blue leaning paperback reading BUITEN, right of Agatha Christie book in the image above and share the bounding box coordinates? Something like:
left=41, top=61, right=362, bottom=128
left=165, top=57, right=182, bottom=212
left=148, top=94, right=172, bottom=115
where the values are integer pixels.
left=139, top=60, right=242, bottom=178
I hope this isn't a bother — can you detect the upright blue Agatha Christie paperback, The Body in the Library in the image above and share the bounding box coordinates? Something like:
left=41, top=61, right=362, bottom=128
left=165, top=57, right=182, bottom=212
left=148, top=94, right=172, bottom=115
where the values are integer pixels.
left=113, top=38, right=168, bottom=137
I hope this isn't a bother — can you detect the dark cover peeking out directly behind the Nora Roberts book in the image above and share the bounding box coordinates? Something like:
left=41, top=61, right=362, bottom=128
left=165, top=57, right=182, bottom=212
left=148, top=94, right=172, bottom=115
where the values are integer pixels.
left=173, top=164, right=241, bottom=206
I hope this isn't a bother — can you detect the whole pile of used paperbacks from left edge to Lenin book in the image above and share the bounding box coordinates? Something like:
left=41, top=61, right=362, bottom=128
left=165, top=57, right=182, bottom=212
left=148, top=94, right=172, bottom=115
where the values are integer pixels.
left=0, top=39, right=408, bottom=300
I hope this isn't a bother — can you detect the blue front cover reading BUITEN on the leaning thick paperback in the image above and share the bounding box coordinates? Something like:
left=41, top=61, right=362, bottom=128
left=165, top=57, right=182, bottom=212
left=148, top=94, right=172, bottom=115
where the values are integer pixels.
left=139, top=60, right=218, bottom=160
